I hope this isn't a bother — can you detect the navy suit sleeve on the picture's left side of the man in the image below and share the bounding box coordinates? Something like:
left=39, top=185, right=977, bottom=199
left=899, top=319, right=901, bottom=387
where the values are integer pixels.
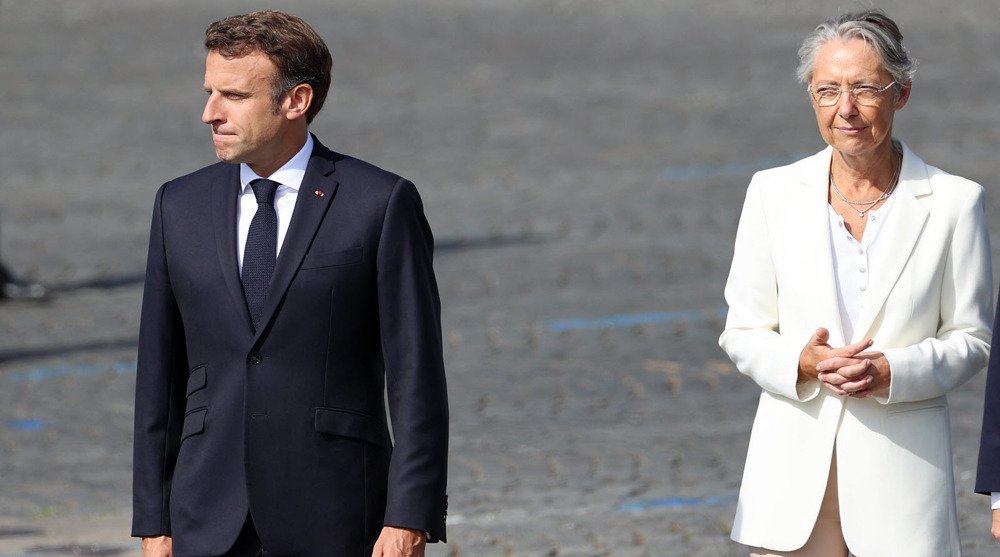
left=132, top=185, right=187, bottom=537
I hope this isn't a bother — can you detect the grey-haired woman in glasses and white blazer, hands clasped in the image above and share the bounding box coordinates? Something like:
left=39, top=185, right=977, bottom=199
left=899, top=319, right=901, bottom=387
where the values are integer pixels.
left=719, top=10, right=993, bottom=557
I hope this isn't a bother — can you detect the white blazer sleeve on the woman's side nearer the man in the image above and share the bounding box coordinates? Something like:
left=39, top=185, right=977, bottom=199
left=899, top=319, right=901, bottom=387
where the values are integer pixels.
left=719, top=173, right=821, bottom=402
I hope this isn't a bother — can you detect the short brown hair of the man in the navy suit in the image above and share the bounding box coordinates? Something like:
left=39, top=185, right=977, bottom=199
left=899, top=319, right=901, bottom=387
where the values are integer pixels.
left=205, top=10, right=333, bottom=123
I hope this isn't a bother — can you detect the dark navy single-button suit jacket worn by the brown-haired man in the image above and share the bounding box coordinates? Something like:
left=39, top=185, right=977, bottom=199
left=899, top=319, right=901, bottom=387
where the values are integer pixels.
left=132, top=136, right=448, bottom=557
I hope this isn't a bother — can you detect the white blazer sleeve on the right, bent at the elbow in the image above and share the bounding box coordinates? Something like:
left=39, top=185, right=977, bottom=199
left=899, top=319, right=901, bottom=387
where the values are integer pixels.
left=877, top=187, right=993, bottom=404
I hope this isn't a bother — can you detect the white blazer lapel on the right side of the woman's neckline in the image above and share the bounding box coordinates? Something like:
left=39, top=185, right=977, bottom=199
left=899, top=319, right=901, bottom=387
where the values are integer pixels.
left=854, top=144, right=931, bottom=339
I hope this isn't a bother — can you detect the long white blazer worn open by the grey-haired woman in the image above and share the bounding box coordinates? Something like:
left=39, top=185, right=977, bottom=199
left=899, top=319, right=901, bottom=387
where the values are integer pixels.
left=719, top=140, right=993, bottom=557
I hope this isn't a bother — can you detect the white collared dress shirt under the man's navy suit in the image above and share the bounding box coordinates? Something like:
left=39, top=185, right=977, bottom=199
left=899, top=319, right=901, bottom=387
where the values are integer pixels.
left=236, top=134, right=313, bottom=274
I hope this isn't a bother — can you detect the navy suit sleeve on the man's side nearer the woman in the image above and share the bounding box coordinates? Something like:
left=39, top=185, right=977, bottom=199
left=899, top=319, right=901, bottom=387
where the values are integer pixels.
left=377, top=179, right=448, bottom=541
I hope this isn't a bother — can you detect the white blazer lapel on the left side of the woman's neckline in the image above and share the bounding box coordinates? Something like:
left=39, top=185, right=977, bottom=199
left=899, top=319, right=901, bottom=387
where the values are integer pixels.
left=789, top=147, right=846, bottom=346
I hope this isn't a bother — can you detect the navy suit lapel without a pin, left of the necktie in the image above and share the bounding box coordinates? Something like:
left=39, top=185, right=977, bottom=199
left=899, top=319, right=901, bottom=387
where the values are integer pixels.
left=211, top=165, right=253, bottom=330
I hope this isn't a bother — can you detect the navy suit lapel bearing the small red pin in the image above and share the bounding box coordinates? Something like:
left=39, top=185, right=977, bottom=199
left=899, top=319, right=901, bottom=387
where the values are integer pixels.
left=254, top=136, right=338, bottom=339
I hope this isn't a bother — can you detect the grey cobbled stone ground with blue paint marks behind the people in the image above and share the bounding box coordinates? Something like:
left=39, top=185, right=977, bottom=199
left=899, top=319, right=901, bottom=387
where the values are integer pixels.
left=0, top=0, right=1000, bottom=557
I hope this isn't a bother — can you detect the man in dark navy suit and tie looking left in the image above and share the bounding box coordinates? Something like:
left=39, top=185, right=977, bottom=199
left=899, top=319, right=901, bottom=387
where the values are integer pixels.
left=132, top=11, right=448, bottom=557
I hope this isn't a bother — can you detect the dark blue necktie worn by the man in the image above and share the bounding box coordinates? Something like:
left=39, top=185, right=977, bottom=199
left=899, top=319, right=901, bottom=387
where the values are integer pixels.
left=242, top=179, right=281, bottom=331
